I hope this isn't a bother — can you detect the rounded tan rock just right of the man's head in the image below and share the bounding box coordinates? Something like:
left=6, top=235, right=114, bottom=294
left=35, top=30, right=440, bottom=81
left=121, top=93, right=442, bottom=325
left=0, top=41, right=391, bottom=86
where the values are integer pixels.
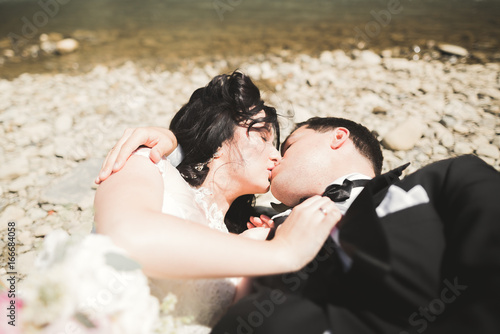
left=382, top=119, right=426, bottom=151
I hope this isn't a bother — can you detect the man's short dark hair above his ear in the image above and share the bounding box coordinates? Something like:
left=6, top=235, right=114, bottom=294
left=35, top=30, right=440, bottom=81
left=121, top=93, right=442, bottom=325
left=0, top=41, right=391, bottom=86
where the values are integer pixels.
left=294, top=117, right=384, bottom=175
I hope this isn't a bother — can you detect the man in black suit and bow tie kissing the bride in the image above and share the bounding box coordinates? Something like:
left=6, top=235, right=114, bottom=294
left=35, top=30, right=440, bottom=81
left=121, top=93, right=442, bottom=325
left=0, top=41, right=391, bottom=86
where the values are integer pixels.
left=97, top=118, right=500, bottom=333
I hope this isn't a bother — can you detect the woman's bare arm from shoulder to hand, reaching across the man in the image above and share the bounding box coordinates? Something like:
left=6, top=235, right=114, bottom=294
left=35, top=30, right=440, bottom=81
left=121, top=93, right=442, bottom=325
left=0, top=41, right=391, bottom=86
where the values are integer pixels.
left=95, top=156, right=340, bottom=278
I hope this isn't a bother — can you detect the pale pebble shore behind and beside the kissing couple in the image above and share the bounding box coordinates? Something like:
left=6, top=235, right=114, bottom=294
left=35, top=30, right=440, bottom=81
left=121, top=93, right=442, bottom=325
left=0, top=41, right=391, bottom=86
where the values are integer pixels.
left=0, top=50, right=500, bottom=284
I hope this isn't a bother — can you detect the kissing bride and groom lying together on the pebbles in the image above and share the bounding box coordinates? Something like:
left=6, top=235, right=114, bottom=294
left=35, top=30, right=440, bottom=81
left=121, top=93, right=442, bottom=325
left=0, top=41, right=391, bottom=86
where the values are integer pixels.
left=95, top=72, right=500, bottom=333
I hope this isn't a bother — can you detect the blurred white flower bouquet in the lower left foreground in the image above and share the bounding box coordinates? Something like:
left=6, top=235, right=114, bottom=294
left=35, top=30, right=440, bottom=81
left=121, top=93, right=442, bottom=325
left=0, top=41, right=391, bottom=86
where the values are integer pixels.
left=19, top=230, right=160, bottom=334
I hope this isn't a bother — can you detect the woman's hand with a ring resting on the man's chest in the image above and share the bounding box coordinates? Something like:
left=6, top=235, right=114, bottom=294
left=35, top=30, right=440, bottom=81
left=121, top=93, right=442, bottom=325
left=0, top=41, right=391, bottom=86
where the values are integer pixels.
left=273, top=196, right=342, bottom=270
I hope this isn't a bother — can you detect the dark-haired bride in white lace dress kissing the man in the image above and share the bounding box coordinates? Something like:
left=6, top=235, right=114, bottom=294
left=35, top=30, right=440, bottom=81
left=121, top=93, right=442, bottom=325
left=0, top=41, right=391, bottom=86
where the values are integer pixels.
left=91, top=72, right=337, bottom=333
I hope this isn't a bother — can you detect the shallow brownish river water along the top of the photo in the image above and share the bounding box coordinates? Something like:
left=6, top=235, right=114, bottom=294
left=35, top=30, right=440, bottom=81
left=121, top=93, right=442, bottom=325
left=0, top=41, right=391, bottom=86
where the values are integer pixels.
left=0, top=0, right=500, bottom=77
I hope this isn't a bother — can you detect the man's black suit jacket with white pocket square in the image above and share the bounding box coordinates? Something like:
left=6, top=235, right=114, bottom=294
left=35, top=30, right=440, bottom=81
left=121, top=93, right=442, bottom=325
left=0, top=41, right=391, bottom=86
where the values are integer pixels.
left=213, top=156, right=500, bottom=334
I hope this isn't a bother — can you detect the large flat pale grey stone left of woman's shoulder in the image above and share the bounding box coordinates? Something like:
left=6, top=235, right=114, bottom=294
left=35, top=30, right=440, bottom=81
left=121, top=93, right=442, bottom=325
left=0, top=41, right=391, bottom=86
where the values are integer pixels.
left=41, top=159, right=102, bottom=205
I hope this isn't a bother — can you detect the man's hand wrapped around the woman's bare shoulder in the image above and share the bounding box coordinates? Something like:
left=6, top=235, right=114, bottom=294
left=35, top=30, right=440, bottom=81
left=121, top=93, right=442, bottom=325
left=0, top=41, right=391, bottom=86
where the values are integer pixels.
left=95, top=127, right=177, bottom=184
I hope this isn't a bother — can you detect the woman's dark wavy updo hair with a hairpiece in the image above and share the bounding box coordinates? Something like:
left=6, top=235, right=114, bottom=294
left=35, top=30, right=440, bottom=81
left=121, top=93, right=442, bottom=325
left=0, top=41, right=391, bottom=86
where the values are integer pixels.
left=170, top=71, right=279, bottom=233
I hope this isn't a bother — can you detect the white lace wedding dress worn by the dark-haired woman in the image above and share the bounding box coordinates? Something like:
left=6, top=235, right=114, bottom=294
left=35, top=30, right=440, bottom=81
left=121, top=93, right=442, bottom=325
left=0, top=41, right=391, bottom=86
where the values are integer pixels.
left=135, top=148, right=238, bottom=333
